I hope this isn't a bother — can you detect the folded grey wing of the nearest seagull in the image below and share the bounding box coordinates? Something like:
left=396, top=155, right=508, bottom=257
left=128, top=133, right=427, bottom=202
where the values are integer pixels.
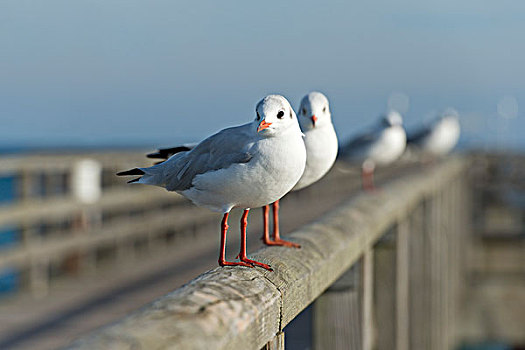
left=154, top=123, right=254, bottom=191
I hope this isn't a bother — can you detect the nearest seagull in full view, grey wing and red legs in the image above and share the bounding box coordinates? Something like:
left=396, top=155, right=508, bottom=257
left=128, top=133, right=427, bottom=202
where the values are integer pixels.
left=117, top=95, right=306, bottom=271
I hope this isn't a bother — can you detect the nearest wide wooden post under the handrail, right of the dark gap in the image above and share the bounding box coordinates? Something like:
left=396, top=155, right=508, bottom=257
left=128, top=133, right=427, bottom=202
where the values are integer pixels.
left=313, top=263, right=363, bottom=350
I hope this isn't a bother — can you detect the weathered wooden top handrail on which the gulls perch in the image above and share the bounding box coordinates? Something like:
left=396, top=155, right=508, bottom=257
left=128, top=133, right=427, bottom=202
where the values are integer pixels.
left=67, top=158, right=464, bottom=350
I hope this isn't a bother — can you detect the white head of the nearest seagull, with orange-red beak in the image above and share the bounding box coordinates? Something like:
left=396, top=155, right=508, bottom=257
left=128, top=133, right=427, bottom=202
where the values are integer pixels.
left=254, top=95, right=299, bottom=137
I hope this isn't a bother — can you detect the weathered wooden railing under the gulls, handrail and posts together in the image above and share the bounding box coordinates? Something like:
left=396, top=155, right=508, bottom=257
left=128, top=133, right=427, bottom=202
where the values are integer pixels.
left=71, top=158, right=470, bottom=349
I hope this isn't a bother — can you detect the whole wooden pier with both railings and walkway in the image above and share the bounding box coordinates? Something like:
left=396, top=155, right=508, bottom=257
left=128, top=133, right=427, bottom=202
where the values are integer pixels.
left=0, top=152, right=525, bottom=349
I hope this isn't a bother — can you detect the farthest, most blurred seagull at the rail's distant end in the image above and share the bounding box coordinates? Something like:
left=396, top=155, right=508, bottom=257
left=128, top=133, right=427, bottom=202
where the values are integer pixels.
left=407, top=109, right=460, bottom=156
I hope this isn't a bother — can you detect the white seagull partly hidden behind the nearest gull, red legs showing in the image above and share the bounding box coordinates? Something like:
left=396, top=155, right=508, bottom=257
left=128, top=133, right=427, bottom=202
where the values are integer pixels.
left=263, top=91, right=338, bottom=248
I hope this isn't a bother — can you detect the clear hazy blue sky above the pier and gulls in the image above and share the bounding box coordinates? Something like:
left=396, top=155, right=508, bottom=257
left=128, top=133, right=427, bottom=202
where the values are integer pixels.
left=0, top=0, right=525, bottom=146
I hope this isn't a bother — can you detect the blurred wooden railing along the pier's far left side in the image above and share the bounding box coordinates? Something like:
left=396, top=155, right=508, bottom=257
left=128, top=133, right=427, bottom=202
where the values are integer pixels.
left=0, top=152, right=210, bottom=297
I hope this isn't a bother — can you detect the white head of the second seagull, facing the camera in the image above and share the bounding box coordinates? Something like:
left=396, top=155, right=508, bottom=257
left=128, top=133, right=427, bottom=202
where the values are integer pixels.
left=299, top=91, right=332, bottom=131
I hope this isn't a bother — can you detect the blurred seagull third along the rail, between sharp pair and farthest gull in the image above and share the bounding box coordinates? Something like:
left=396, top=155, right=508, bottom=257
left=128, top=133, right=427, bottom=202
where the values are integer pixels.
left=342, top=111, right=406, bottom=191
